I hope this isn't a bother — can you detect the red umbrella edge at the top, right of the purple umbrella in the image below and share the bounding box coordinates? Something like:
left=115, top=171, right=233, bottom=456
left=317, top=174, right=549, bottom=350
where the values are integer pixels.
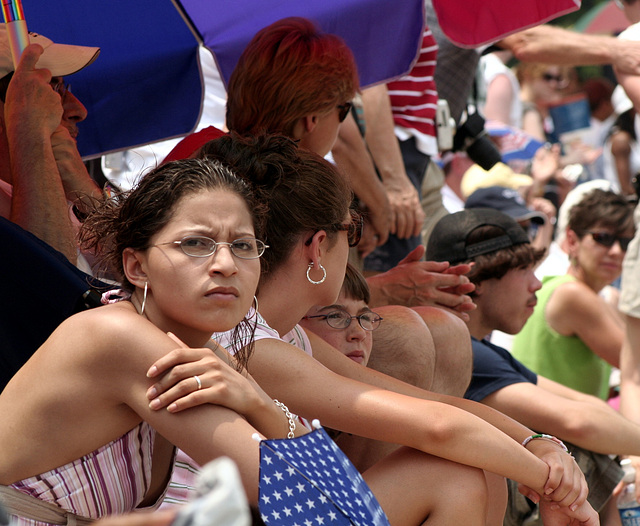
left=433, top=0, right=581, bottom=48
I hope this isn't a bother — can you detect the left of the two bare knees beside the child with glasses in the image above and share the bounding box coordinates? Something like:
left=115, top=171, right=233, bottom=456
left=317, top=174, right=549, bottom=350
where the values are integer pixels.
left=368, top=305, right=436, bottom=389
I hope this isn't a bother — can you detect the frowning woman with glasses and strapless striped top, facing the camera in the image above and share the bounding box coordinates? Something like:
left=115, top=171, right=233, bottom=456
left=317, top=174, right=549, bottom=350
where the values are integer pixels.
left=0, top=160, right=312, bottom=525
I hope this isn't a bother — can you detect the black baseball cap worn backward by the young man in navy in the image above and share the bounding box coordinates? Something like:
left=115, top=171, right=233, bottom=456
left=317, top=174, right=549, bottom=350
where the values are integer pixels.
left=426, top=208, right=529, bottom=265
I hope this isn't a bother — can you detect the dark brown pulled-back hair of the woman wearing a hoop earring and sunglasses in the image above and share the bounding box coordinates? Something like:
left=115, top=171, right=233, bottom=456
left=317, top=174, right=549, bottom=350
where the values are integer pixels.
left=199, top=133, right=352, bottom=275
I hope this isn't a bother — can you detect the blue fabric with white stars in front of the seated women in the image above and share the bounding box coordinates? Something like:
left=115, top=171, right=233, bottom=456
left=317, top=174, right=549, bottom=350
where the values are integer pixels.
left=259, top=421, right=389, bottom=526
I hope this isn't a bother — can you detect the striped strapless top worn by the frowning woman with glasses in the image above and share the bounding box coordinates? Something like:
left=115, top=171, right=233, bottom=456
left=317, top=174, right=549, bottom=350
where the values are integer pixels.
left=11, top=422, right=169, bottom=526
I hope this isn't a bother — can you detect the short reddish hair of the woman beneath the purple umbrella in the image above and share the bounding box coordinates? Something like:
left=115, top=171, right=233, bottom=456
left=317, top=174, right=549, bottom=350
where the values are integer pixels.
left=227, top=17, right=358, bottom=137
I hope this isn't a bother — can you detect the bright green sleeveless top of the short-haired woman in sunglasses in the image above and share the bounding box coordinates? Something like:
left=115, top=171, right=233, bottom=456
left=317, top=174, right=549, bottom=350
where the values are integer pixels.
left=512, top=275, right=611, bottom=400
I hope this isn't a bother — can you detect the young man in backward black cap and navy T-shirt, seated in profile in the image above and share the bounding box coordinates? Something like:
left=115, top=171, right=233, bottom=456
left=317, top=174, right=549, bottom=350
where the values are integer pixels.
left=427, top=208, right=640, bottom=525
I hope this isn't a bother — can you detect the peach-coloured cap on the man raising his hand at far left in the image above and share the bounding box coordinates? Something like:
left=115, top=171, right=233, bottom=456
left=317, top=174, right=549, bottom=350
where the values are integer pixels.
left=0, top=24, right=100, bottom=78
